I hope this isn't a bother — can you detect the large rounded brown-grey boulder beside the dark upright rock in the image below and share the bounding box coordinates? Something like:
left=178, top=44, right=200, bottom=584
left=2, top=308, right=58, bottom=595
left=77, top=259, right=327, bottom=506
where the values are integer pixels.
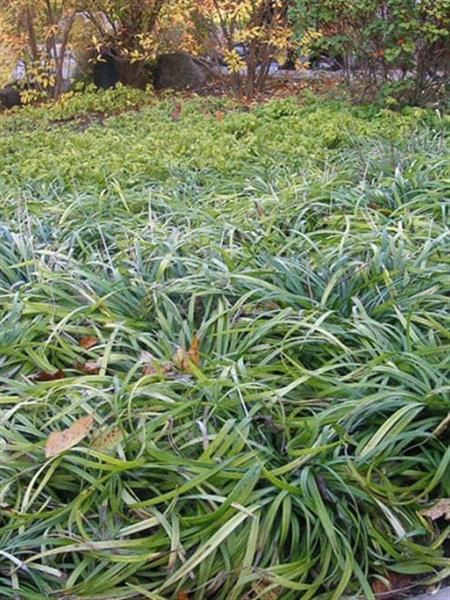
left=154, top=52, right=209, bottom=91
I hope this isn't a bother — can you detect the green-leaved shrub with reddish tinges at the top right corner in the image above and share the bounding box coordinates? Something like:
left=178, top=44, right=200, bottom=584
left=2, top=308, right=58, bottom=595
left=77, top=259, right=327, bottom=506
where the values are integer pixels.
left=291, top=0, right=450, bottom=105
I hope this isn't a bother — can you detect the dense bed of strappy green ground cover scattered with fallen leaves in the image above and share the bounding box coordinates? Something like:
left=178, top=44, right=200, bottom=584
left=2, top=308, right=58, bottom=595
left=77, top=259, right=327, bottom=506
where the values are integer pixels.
left=0, top=90, right=450, bottom=600
